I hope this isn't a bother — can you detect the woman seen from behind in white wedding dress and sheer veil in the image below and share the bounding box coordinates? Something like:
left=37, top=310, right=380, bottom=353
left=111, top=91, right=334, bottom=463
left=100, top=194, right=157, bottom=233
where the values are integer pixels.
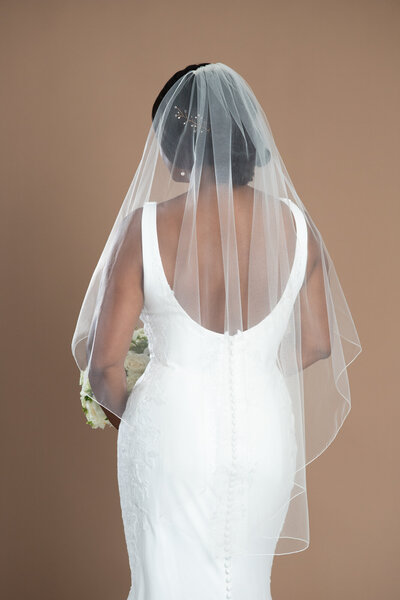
left=72, top=63, right=361, bottom=600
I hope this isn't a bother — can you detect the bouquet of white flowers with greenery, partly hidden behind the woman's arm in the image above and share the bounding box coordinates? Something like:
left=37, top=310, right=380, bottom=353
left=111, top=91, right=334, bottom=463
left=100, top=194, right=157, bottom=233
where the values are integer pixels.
left=79, top=327, right=150, bottom=429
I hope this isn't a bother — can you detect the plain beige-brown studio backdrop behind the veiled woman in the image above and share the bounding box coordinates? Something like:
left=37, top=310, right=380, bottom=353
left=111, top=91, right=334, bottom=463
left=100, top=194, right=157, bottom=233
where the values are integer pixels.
left=0, top=0, right=400, bottom=600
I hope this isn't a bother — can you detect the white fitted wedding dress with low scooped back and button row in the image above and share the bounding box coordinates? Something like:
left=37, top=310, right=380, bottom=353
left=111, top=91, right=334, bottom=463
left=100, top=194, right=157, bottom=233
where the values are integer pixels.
left=118, top=200, right=307, bottom=600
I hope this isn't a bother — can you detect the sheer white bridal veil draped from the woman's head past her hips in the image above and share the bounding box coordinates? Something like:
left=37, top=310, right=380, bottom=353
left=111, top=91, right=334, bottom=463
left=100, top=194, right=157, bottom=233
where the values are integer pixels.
left=72, top=62, right=361, bottom=554
